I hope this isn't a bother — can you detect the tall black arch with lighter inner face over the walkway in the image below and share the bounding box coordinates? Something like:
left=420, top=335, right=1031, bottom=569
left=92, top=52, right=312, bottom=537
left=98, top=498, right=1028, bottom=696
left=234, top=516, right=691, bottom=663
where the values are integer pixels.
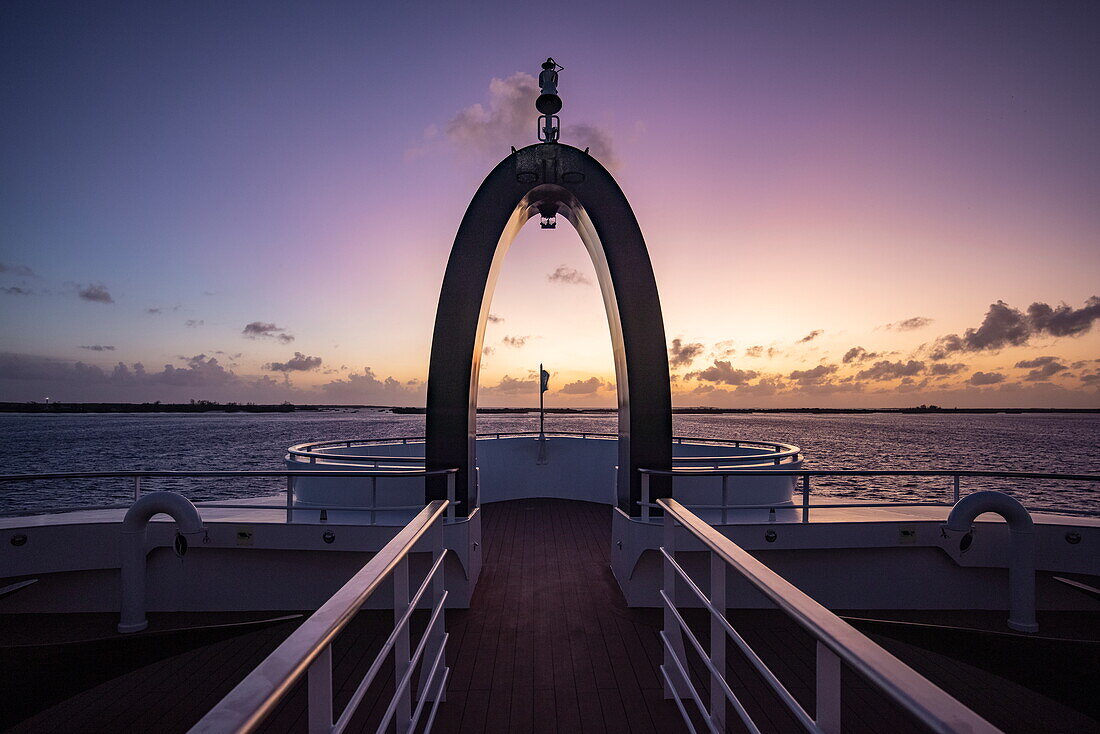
left=425, top=143, right=672, bottom=515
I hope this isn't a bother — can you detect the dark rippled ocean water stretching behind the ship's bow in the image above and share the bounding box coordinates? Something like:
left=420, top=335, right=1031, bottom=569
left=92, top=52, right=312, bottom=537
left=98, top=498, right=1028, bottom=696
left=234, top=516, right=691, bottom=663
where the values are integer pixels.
left=0, top=409, right=1100, bottom=514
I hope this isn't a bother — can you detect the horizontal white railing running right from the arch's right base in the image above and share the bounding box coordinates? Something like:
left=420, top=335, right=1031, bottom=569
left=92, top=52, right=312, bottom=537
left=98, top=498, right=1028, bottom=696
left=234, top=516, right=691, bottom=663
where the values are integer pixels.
left=638, top=468, right=1100, bottom=523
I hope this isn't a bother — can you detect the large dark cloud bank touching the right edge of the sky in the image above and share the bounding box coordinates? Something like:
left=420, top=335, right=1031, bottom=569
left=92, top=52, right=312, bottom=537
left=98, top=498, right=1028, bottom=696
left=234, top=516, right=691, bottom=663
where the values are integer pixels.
left=932, top=296, right=1100, bottom=360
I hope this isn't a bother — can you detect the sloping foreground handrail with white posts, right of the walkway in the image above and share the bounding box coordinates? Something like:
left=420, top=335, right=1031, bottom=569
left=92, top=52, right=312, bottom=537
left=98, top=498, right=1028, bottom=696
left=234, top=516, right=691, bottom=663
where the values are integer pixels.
left=657, top=500, right=998, bottom=734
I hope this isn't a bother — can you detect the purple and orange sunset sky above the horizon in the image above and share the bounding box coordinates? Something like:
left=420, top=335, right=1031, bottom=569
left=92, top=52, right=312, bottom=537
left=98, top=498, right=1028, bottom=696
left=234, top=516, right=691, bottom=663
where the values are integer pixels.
left=0, top=2, right=1100, bottom=407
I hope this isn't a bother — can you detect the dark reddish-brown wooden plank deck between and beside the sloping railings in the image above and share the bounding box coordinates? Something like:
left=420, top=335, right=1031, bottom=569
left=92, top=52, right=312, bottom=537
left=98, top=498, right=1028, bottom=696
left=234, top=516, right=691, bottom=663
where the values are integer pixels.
left=4, top=500, right=1097, bottom=734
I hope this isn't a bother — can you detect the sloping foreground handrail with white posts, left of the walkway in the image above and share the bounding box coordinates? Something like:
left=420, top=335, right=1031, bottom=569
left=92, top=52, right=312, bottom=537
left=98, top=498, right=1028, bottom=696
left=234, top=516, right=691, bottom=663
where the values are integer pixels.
left=190, top=500, right=450, bottom=734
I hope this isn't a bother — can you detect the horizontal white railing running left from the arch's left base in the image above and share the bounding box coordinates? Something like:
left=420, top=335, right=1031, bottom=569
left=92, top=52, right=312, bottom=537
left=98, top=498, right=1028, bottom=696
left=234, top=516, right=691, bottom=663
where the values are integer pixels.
left=0, top=469, right=462, bottom=524
